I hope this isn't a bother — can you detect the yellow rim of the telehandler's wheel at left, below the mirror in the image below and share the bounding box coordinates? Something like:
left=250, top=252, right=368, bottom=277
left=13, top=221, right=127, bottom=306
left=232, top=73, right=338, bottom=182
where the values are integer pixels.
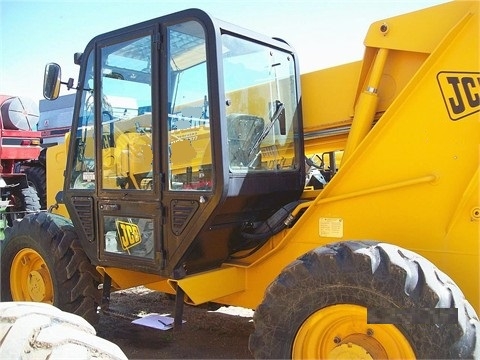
left=10, top=248, right=53, bottom=304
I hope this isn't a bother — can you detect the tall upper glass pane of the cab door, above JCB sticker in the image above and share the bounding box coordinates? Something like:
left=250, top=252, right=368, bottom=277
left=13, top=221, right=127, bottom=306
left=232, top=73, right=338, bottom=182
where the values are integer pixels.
left=101, top=35, right=153, bottom=190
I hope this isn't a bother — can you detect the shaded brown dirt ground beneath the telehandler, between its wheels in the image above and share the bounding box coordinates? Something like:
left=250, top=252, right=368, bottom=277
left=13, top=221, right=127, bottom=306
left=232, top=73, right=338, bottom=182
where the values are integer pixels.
left=96, top=287, right=253, bottom=359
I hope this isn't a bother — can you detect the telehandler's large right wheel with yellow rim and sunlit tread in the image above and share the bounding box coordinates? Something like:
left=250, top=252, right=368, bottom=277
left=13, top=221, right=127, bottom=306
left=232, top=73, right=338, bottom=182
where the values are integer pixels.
left=249, top=241, right=480, bottom=359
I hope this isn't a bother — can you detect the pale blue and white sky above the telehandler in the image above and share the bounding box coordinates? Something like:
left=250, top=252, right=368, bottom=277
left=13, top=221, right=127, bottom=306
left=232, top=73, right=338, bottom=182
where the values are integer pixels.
left=0, top=0, right=446, bottom=101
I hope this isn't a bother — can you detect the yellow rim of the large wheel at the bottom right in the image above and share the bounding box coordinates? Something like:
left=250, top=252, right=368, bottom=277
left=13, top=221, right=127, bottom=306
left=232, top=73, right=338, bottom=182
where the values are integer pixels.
left=292, top=304, right=415, bottom=359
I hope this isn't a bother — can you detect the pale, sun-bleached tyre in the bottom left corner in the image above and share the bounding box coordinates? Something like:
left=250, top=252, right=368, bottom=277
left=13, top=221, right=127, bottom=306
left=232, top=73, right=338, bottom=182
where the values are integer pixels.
left=0, top=302, right=127, bottom=360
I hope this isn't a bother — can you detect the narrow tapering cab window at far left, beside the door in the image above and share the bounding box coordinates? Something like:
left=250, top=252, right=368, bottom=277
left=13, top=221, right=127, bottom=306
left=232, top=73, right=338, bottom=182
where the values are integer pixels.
left=70, top=52, right=95, bottom=189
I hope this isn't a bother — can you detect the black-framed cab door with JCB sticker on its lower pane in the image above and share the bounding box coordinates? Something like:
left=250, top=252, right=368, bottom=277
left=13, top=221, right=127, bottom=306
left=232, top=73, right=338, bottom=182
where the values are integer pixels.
left=97, top=29, right=162, bottom=268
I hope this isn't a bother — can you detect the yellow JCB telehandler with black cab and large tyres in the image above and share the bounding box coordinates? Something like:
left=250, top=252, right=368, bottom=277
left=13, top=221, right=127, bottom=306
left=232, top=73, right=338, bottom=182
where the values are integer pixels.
left=1, top=1, right=480, bottom=359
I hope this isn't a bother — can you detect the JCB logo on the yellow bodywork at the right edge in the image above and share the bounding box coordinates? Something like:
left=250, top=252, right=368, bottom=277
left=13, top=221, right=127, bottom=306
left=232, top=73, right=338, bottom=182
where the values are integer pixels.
left=437, top=71, right=480, bottom=120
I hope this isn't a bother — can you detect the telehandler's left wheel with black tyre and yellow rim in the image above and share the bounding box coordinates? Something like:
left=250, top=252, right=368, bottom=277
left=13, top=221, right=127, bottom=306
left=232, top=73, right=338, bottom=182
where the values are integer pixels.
left=1, top=212, right=101, bottom=323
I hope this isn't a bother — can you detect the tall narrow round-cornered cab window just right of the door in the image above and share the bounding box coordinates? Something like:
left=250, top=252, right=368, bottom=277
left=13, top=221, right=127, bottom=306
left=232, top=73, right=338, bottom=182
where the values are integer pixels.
left=167, top=21, right=213, bottom=191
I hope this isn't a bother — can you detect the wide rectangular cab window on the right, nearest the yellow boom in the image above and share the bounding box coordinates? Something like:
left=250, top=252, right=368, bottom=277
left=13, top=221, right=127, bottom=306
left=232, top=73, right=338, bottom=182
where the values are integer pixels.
left=222, top=34, right=299, bottom=173
